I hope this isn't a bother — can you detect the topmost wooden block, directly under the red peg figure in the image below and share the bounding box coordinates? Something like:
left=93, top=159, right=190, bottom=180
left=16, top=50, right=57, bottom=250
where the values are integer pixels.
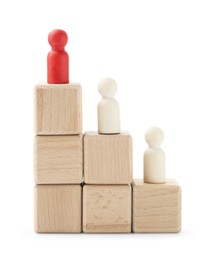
left=35, top=84, right=82, bottom=135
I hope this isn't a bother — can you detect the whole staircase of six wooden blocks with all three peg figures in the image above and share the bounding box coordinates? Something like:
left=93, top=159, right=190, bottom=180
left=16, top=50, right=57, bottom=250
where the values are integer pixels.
left=35, top=30, right=181, bottom=233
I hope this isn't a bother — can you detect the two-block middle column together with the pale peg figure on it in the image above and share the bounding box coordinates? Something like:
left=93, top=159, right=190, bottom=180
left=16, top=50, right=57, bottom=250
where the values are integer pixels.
left=83, top=78, right=132, bottom=233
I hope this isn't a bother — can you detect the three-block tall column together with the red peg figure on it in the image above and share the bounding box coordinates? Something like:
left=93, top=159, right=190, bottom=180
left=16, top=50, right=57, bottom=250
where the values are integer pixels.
left=34, top=30, right=83, bottom=232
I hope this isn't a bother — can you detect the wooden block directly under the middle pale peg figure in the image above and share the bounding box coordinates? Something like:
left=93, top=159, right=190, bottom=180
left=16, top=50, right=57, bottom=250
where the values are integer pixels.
left=84, top=132, right=132, bottom=184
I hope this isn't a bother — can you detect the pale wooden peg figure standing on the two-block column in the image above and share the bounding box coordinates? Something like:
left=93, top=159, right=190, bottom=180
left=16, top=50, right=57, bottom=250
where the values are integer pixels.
left=97, top=78, right=120, bottom=134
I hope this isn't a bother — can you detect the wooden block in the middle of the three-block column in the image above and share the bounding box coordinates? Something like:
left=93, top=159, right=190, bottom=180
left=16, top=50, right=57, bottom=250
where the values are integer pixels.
left=34, top=135, right=83, bottom=184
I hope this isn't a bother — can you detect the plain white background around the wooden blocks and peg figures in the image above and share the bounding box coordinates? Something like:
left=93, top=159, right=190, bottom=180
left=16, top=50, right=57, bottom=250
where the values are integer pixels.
left=0, top=0, right=214, bottom=260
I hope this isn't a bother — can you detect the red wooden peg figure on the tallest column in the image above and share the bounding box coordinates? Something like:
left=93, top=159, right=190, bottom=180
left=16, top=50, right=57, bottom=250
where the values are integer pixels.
left=47, top=30, right=69, bottom=84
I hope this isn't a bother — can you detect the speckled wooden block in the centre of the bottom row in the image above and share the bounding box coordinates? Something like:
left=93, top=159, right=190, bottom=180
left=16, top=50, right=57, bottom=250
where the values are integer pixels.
left=83, top=185, right=131, bottom=233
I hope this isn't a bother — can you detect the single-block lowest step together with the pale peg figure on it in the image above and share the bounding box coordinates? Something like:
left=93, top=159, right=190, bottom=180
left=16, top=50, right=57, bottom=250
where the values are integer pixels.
left=132, top=127, right=181, bottom=233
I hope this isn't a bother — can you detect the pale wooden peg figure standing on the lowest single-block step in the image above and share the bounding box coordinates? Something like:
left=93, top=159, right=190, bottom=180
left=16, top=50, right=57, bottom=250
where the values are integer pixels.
left=144, top=127, right=165, bottom=183
